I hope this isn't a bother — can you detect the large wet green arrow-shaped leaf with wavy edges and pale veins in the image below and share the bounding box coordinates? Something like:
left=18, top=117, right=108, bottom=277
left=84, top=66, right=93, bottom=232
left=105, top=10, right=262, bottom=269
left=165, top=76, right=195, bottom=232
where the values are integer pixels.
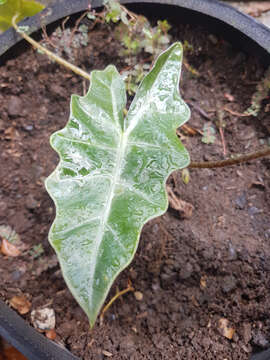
left=46, top=42, right=189, bottom=326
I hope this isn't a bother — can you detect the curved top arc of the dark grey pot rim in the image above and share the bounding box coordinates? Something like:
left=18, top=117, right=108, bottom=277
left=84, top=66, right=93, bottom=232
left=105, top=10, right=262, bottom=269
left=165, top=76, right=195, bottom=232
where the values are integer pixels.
left=0, top=0, right=270, bottom=57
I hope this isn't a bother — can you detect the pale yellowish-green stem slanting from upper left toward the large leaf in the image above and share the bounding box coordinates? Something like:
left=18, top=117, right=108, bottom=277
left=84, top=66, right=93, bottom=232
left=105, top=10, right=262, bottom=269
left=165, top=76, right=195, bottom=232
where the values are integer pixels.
left=12, top=13, right=90, bottom=80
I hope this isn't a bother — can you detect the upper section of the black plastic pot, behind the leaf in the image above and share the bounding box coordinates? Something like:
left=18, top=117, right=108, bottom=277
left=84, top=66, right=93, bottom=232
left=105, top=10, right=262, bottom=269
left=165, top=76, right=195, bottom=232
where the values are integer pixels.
left=0, top=0, right=270, bottom=64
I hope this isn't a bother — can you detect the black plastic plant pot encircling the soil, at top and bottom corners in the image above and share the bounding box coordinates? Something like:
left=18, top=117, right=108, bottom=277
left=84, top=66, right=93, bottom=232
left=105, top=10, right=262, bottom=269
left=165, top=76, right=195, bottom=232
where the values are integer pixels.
left=0, top=0, right=270, bottom=360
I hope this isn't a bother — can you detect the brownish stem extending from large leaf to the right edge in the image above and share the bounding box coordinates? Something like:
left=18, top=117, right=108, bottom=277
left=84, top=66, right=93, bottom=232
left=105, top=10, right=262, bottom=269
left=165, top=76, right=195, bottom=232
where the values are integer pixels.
left=188, top=146, right=270, bottom=168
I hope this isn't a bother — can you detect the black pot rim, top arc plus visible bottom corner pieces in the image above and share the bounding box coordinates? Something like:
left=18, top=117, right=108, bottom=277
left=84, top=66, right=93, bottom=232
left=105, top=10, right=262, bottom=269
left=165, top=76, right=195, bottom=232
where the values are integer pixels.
left=0, top=0, right=270, bottom=360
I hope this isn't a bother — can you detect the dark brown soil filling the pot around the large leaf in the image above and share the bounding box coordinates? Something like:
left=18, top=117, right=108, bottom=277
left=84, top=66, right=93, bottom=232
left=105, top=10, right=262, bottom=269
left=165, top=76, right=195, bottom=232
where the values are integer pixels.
left=0, top=11, right=270, bottom=360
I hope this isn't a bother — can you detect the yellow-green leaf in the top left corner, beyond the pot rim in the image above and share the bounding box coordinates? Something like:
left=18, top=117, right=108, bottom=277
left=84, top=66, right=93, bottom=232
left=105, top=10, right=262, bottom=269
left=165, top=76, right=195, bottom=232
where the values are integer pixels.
left=0, top=0, right=44, bottom=31
